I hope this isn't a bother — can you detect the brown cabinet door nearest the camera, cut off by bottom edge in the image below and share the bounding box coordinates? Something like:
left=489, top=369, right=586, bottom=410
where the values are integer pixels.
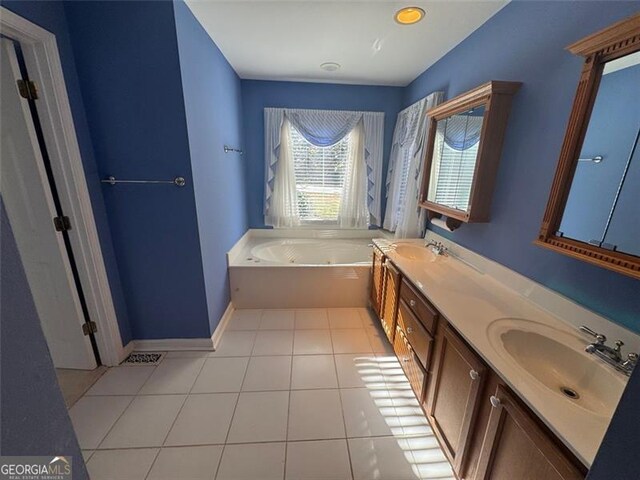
left=475, top=385, right=584, bottom=480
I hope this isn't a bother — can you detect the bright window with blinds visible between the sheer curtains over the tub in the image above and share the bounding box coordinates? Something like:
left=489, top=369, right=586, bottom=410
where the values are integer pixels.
left=291, top=123, right=351, bottom=224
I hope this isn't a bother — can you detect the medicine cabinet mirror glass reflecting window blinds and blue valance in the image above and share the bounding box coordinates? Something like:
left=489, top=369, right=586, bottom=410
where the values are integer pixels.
left=427, top=105, right=485, bottom=212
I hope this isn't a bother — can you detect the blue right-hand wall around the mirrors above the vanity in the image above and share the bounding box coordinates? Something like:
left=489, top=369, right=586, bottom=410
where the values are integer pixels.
left=404, top=2, right=640, bottom=332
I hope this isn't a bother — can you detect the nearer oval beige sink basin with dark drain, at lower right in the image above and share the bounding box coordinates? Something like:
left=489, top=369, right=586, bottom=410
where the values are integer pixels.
left=488, top=319, right=625, bottom=417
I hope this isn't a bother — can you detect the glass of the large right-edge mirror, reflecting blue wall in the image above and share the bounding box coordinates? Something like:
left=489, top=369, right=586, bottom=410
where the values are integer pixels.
left=559, top=52, right=640, bottom=256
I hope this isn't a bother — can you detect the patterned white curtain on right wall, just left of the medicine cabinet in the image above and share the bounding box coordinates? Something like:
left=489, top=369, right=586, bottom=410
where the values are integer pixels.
left=383, top=92, right=444, bottom=238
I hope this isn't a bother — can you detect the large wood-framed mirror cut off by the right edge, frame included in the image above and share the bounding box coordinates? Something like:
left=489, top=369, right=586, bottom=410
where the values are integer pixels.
left=535, top=13, right=640, bottom=278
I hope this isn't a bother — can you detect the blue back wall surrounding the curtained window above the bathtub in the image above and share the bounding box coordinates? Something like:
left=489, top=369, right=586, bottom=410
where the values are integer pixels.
left=242, top=80, right=403, bottom=228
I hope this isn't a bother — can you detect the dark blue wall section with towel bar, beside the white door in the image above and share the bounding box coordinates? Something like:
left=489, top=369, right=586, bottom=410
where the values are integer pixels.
left=65, top=1, right=210, bottom=339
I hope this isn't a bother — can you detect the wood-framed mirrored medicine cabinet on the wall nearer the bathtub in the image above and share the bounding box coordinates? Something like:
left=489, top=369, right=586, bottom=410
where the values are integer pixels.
left=420, top=80, right=522, bottom=230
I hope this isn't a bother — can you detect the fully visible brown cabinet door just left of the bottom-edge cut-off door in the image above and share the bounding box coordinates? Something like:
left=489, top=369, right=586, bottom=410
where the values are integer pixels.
left=426, top=324, right=488, bottom=478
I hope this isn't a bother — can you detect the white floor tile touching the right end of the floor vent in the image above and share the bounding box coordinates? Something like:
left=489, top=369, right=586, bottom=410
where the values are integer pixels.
left=139, top=358, right=205, bottom=395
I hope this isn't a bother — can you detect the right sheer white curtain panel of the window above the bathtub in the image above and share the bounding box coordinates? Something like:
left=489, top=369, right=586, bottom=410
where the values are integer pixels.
left=338, top=120, right=369, bottom=228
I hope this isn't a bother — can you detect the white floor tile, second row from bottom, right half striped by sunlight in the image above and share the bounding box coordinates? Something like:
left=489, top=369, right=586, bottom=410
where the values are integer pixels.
left=340, top=388, right=403, bottom=437
